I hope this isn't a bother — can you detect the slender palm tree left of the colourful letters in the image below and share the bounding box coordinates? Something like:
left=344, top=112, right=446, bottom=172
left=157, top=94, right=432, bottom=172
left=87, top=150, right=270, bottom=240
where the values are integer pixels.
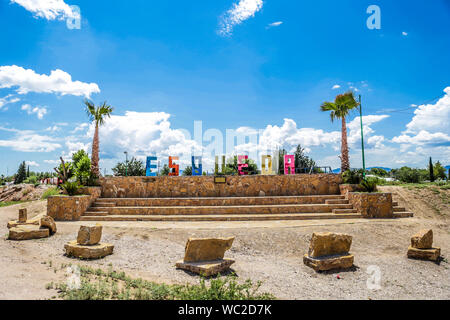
left=84, top=100, right=114, bottom=177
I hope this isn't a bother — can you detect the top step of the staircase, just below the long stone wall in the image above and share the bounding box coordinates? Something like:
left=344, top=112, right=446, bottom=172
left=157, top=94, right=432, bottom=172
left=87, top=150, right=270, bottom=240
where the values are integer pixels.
left=94, top=195, right=344, bottom=207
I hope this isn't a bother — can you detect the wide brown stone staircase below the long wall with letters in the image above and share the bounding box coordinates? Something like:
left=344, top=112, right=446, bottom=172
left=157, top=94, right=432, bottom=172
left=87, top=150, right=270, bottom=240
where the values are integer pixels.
left=80, top=195, right=362, bottom=221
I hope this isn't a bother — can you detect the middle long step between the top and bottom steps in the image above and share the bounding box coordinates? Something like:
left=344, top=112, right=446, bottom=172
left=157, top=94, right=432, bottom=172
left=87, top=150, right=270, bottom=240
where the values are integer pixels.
left=85, top=204, right=353, bottom=215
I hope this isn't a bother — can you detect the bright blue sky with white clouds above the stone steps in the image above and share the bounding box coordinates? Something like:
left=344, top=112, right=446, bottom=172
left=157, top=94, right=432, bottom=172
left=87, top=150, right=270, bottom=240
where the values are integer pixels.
left=0, top=0, right=450, bottom=174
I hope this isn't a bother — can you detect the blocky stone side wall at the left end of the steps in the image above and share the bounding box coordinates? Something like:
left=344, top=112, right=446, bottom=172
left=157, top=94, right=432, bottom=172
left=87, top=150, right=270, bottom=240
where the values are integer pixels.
left=47, top=187, right=101, bottom=221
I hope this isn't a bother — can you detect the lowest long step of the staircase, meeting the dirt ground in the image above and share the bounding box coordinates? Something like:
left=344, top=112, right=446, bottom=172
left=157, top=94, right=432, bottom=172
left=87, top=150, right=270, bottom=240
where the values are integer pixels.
left=80, top=213, right=362, bottom=221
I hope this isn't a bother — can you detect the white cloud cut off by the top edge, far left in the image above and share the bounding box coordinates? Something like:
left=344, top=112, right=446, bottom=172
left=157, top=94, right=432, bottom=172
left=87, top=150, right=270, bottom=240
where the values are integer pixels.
left=11, top=0, right=77, bottom=20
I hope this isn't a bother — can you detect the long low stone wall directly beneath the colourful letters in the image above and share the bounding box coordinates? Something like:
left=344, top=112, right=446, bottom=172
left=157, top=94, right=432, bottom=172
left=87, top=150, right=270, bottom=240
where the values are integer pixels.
left=100, top=174, right=342, bottom=198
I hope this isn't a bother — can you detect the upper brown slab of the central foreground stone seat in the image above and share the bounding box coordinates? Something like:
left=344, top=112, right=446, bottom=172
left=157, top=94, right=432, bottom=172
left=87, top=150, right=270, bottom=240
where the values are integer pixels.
left=184, top=237, right=234, bottom=262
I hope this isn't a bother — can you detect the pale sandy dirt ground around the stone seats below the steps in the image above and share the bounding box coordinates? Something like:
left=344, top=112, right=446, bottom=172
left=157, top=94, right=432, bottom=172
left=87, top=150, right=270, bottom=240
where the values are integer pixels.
left=0, top=187, right=450, bottom=299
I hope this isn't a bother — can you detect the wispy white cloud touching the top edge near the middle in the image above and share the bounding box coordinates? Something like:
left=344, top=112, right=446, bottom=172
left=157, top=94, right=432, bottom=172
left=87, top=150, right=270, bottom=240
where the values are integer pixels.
left=219, top=0, right=263, bottom=36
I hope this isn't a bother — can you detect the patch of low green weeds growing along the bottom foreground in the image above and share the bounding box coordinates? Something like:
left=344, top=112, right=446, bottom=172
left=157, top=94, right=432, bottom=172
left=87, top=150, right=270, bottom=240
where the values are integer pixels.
left=57, top=266, right=275, bottom=300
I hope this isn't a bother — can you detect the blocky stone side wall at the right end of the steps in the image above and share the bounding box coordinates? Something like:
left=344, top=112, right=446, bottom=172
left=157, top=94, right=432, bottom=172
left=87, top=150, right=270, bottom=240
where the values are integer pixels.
left=348, top=192, right=394, bottom=218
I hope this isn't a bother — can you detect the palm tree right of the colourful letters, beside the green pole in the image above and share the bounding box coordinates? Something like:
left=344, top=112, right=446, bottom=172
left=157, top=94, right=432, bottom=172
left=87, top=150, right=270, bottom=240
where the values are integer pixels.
left=320, top=91, right=359, bottom=173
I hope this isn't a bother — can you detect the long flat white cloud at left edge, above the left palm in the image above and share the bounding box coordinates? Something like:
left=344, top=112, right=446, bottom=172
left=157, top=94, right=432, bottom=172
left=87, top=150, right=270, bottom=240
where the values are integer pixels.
left=0, top=65, right=100, bottom=98
